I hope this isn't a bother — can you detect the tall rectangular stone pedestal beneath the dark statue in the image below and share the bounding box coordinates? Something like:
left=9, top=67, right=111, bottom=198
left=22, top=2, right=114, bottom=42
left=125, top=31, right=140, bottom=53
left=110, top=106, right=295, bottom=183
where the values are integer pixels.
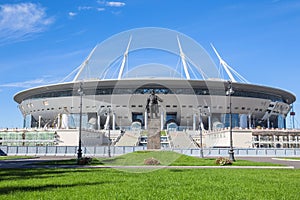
left=147, top=118, right=161, bottom=149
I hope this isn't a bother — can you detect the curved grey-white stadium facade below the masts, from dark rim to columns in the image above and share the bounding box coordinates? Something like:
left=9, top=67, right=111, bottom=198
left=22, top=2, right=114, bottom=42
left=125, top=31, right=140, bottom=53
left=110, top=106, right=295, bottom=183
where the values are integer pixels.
left=15, top=79, right=295, bottom=130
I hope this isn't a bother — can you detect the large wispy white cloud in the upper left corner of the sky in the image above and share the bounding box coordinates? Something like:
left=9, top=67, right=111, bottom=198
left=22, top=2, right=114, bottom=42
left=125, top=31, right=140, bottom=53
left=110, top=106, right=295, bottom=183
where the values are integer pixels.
left=0, top=3, right=54, bottom=44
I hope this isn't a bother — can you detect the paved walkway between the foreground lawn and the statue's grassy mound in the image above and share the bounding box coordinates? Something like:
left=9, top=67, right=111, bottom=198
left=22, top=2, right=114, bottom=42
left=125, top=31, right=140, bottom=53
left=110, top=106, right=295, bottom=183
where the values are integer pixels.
left=0, top=156, right=300, bottom=169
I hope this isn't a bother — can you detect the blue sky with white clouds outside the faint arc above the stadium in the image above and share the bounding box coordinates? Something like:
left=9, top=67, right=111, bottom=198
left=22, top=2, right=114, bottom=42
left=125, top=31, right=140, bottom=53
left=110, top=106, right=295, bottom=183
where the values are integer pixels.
left=0, top=0, right=300, bottom=128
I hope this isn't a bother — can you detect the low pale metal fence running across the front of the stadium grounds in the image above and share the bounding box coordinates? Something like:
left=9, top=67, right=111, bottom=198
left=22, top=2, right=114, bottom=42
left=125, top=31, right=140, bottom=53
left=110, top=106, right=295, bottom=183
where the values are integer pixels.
left=0, top=146, right=300, bottom=157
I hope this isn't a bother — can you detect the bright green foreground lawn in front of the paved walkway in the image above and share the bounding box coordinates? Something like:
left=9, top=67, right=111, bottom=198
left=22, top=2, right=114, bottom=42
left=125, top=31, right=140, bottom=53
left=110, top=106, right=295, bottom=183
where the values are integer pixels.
left=0, top=168, right=300, bottom=200
